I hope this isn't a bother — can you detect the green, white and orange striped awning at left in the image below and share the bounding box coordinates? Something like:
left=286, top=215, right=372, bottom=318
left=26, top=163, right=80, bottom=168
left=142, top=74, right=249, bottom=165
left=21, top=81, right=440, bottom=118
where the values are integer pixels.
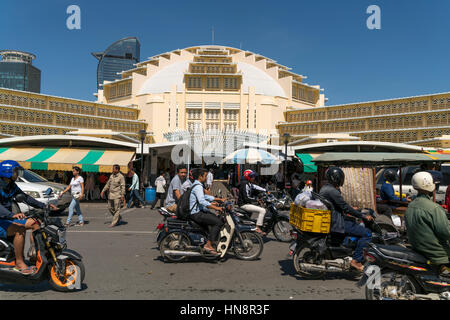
left=0, top=148, right=135, bottom=172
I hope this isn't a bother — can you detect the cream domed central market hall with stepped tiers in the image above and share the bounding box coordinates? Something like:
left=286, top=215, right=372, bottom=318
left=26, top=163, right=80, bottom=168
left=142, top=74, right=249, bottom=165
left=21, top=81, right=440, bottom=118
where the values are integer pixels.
left=96, top=45, right=325, bottom=142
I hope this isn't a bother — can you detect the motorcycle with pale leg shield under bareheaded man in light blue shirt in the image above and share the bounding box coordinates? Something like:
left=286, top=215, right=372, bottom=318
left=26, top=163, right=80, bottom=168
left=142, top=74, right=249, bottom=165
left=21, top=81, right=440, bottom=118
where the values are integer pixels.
left=157, top=203, right=264, bottom=262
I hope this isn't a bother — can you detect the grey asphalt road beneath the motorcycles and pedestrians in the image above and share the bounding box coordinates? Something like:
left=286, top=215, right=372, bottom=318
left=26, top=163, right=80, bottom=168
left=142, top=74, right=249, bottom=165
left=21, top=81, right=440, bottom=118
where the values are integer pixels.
left=0, top=203, right=364, bottom=300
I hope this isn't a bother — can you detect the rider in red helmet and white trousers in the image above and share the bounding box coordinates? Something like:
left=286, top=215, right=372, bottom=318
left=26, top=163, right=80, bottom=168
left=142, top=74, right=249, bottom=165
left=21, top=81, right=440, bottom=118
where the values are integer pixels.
left=238, top=170, right=266, bottom=235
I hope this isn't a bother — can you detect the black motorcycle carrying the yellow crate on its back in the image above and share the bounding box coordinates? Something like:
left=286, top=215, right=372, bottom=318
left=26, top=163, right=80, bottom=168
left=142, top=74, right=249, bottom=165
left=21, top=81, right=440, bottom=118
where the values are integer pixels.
left=289, top=194, right=400, bottom=279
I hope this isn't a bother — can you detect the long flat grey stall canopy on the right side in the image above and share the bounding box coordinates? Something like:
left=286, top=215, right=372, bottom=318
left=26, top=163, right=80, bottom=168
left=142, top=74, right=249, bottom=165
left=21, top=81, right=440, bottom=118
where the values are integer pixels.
left=312, top=152, right=450, bottom=165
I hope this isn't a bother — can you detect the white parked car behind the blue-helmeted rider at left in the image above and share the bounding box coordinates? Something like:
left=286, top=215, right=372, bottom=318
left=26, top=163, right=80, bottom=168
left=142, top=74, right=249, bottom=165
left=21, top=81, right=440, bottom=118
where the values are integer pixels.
left=13, top=170, right=72, bottom=213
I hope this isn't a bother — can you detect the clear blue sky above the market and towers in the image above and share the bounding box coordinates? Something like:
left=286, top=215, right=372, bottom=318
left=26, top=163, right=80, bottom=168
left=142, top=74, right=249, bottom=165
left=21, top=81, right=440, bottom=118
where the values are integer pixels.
left=0, top=0, right=450, bottom=105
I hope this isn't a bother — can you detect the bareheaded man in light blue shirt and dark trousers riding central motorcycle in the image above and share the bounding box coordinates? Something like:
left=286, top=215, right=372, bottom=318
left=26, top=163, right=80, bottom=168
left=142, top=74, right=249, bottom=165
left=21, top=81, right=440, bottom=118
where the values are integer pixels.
left=189, top=169, right=224, bottom=255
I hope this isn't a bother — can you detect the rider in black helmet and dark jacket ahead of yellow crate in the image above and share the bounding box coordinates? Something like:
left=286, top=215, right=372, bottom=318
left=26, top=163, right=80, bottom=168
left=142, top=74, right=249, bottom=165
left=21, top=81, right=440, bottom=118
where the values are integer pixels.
left=319, top=167, right=373, bottom=271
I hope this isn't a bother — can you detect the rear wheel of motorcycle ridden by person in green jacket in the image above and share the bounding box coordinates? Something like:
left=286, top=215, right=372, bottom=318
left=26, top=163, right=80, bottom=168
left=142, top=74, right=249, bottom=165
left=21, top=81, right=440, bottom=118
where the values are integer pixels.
left=366, top=270, right=422, bottom=300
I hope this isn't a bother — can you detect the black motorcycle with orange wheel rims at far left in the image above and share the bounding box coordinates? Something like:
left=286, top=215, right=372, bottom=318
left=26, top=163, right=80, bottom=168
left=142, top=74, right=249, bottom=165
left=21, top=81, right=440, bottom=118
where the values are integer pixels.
left=0, top=188, right=85, bottom=292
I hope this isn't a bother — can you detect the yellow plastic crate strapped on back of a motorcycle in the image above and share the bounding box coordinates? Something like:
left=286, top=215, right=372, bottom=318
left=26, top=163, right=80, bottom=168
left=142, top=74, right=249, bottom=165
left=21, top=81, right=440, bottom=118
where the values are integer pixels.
left=289, top=203, right=331, bottom=233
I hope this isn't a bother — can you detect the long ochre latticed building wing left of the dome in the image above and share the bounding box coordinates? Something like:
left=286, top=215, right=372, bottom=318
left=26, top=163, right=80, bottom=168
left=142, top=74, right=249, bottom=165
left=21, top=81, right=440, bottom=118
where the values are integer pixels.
left=0, top=88, right=148, bottom=141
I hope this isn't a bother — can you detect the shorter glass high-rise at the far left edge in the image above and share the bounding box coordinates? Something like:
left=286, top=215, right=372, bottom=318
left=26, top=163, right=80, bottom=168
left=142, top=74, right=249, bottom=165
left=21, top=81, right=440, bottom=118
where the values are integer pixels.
left=0, top=50, right=41, bottom=93
